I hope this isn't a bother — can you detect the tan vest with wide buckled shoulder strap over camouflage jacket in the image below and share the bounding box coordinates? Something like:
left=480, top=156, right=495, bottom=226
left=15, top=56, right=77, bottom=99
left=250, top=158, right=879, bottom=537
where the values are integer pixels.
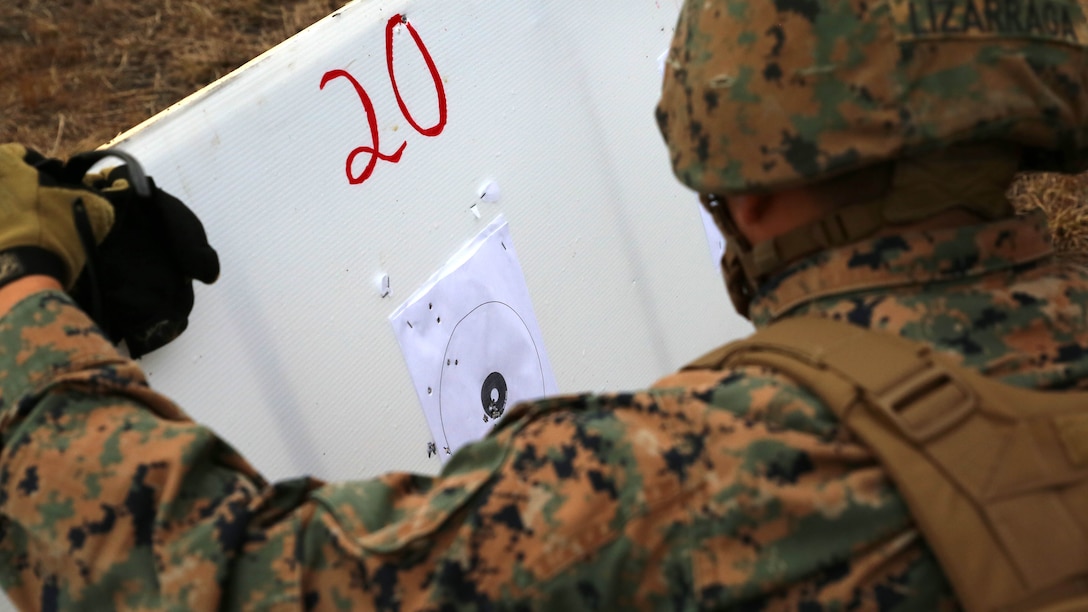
left=687, top=317, right=1088, bottom=612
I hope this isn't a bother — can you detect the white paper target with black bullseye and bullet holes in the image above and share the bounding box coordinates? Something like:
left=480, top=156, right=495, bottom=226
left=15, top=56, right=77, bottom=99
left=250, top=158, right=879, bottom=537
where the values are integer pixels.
left=390, top=216, right=557, bottom=463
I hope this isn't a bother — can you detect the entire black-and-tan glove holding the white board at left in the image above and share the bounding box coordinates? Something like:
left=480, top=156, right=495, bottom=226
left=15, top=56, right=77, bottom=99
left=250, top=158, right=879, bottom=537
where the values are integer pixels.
left=0, top=144, right=219, bottom=357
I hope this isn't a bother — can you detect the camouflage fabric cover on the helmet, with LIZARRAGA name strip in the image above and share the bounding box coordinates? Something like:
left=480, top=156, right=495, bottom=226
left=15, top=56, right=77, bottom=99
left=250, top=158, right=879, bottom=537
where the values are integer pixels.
left=657, top=0, right=1088, bottom=194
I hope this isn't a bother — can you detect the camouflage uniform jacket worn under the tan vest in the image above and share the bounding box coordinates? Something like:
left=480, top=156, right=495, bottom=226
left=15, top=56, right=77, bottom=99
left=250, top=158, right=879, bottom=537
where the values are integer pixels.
left=0, top=207, right=1088, bottom=612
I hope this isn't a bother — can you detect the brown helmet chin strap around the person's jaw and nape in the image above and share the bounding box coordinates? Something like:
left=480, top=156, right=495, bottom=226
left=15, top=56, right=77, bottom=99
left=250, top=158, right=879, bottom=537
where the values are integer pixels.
left=701, top=143, right=1021, bottom=317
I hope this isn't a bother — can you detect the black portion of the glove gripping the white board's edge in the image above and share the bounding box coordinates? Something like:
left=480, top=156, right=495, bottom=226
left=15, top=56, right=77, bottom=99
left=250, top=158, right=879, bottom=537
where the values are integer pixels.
left=72, top=166, right=219, bottom=357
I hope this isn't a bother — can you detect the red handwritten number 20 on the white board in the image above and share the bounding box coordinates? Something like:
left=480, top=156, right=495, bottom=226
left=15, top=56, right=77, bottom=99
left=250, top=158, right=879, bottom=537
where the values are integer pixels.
left=320, top=15, right=446, bottom=185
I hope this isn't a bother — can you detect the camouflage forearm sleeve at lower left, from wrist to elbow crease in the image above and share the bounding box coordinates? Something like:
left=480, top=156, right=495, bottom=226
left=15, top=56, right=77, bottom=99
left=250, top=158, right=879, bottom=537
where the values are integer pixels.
left=0, top=292, right=285, bottom=610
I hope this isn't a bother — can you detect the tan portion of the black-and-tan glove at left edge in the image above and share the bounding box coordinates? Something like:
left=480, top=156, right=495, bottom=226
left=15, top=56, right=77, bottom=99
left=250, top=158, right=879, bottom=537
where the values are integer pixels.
left=0, top=144, right=113, bottom=289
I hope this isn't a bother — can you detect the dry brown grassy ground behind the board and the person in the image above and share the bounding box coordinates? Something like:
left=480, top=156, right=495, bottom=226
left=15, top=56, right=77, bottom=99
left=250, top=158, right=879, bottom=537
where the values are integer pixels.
left=0, top=0, right=1088, bottom=255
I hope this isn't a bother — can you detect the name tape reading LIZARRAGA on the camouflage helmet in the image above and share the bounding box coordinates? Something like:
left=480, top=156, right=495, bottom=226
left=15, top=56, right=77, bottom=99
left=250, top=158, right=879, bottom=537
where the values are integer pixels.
left=891, top=0, right=1088, bottom=46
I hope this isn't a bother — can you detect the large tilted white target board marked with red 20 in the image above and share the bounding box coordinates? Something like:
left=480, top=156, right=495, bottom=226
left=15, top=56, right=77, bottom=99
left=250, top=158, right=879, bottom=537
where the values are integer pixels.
left=112, top=0, right=747, bottom=479
